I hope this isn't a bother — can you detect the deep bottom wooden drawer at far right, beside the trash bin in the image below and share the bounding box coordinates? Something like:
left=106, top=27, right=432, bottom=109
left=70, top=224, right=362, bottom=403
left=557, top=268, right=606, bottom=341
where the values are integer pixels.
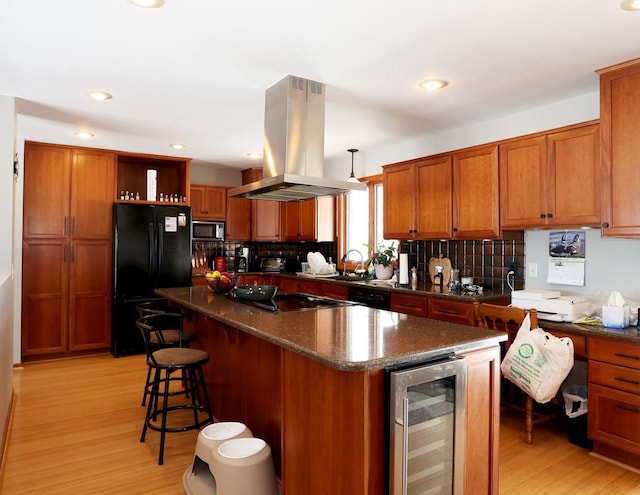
left=588, top=383, right=640, bottom=454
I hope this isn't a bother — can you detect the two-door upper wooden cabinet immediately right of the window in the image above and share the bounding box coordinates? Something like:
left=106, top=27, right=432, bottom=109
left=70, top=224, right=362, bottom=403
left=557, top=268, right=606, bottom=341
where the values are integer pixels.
left=383, top=155, right=452, bottom=239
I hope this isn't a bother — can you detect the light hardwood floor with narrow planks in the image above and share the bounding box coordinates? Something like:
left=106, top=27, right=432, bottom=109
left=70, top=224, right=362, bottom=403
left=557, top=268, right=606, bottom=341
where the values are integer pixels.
left=0, top=355, right=640, bottom=495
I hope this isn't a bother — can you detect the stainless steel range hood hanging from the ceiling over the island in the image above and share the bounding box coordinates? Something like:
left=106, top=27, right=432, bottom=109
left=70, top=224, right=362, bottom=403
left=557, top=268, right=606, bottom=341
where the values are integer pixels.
left=229, top=75, right=367, bottom=201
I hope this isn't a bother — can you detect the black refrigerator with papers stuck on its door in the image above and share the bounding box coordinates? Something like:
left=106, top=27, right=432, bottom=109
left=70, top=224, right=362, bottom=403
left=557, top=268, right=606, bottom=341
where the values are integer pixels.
left=111, top=203, right=191, bottom=357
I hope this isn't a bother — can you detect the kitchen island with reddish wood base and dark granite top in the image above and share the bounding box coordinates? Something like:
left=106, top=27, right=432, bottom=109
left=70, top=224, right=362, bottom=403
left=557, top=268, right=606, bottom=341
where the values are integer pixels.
left=157, top=287, right=506, bottom=495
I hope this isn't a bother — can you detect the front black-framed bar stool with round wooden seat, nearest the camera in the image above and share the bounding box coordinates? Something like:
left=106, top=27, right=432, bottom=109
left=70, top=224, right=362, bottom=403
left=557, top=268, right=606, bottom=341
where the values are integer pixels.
left=136, top=313, right=213, bottom=465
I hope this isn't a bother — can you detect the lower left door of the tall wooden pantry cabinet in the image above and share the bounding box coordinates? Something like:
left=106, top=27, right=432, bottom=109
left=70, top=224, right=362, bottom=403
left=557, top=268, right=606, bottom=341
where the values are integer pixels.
left=22, top=239, right=70, bottom=356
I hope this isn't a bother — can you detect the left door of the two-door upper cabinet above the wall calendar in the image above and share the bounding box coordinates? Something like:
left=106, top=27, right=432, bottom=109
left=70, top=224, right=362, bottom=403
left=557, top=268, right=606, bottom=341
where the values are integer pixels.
left=500, top=136, right=550, bottom=228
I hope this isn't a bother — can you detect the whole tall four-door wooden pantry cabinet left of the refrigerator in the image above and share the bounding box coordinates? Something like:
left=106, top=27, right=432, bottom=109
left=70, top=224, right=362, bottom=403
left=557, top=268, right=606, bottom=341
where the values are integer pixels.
left=22, top=142, right=116, bottom=357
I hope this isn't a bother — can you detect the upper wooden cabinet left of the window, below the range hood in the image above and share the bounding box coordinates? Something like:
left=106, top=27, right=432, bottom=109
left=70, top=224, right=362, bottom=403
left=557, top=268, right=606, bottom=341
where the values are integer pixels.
left=281, top=196, right=336, bottom=242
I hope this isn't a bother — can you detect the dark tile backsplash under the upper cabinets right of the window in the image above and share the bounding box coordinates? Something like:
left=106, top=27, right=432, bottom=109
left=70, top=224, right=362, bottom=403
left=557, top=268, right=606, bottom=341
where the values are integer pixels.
left=399, top=232, right=525, bottom=290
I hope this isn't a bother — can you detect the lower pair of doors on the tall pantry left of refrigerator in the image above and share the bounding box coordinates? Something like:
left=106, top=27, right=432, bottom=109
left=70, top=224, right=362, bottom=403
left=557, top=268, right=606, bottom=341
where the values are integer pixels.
left=22, top=239, right=112, bottom=357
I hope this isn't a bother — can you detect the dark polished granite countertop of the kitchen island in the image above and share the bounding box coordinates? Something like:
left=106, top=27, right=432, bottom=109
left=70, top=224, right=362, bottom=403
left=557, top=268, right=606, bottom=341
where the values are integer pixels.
left=156, top=287, right=506, bottom=371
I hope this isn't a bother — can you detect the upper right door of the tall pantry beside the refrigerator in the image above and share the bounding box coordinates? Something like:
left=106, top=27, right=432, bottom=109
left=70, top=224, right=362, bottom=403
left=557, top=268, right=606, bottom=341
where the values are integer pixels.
left=69, top=150, right=116, bottom=239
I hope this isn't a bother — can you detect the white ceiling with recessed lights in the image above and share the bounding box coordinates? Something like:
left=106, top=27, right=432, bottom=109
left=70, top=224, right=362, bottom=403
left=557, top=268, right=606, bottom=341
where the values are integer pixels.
left=0, top=0, right=640, bottom=173
